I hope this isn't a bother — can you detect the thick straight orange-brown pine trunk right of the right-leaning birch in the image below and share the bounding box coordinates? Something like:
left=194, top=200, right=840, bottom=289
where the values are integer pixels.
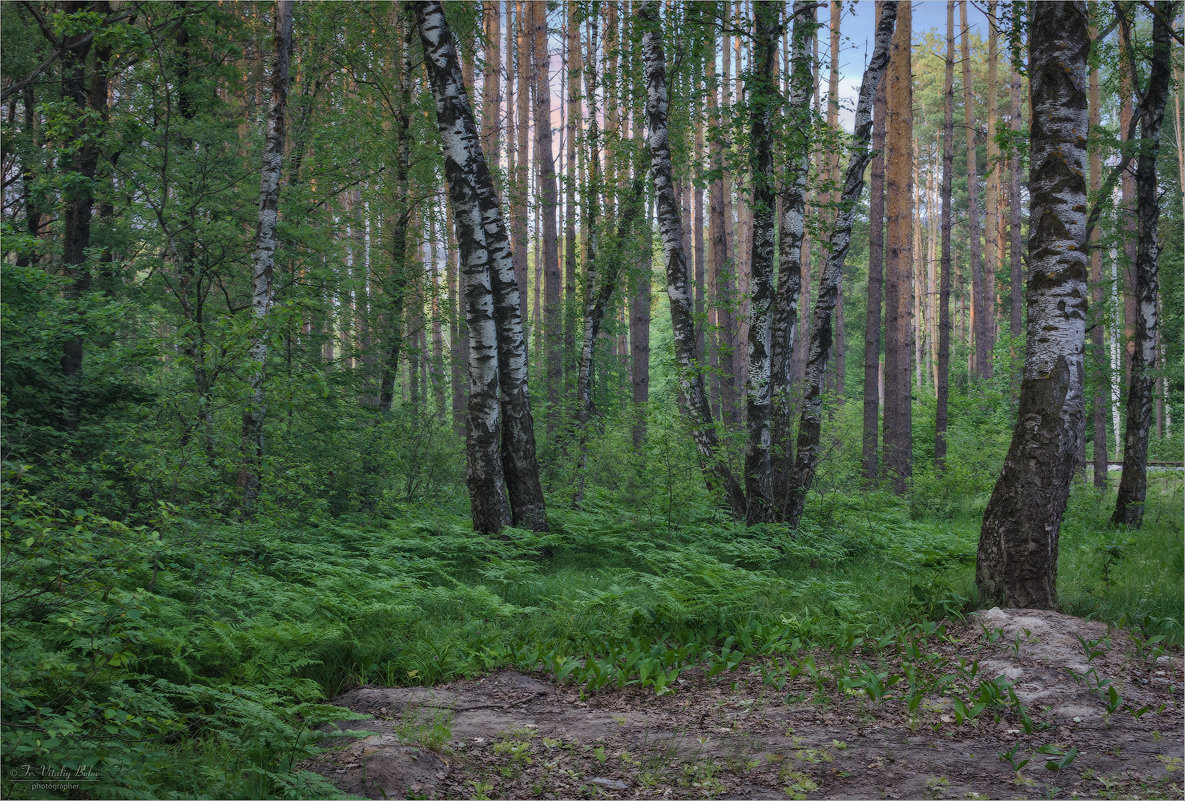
left=884, top=0, right=914, bottom=493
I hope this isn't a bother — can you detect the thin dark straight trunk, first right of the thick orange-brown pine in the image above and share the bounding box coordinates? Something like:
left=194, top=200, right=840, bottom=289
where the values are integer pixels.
left=934, top=0, right=955, bottom=469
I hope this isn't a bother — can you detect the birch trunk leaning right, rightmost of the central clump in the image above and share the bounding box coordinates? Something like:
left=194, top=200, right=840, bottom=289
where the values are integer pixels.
left=786, top=0, right=895, bottom=528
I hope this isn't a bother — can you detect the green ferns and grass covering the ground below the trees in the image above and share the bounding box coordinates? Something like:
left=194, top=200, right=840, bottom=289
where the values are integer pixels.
left=2, top=466, right=1181, bottom=797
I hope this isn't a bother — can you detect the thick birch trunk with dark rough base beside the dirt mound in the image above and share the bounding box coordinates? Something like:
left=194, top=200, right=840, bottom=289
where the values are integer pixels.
left=975, top=1, right=1090, bottom=609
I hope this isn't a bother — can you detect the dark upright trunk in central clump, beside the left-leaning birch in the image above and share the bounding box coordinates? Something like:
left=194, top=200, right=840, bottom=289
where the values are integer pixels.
left=744, top=4, right=780, bottom=523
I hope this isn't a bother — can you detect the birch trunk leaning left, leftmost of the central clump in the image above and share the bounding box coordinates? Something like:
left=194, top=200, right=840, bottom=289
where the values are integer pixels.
left=638, top=2, right=745, bottom=517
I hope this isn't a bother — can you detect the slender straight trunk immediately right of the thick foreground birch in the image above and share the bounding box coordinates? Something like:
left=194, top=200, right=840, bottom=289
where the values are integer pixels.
left=1085, top=12, right=1110, bottom=489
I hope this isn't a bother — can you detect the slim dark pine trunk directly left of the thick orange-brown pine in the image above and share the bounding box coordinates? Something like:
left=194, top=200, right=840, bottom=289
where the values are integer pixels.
left=863, top=0, right=888, bottom=481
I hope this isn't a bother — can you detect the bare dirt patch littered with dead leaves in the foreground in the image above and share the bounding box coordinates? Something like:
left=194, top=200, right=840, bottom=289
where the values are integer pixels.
left=305, top=609, right=1185, bottom=799
